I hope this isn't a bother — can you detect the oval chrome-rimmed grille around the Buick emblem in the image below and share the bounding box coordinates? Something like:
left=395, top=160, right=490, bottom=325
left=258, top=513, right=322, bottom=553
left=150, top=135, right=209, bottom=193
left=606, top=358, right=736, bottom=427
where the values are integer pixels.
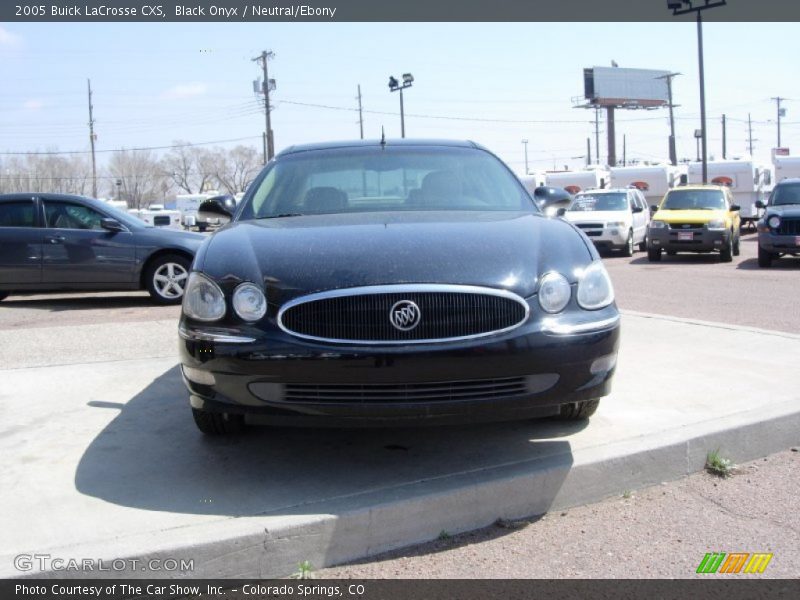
left=278, top=284, right=528, bottom=344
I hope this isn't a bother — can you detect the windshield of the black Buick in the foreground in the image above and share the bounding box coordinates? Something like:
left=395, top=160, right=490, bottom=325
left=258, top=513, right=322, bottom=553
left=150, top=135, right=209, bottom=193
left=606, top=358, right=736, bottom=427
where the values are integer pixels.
left=237, top=146, right=538, bottom=220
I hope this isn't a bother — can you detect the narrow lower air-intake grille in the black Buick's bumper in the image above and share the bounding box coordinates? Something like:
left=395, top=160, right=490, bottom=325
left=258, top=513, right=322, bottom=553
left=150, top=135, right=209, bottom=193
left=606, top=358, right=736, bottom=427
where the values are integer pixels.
left=283, top=377, right=528, bottom=404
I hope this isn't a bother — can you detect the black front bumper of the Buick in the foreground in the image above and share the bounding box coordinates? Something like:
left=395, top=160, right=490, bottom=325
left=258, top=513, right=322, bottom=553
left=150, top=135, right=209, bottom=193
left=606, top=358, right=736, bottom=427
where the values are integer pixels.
left=180, top=306, right=619, bottom=426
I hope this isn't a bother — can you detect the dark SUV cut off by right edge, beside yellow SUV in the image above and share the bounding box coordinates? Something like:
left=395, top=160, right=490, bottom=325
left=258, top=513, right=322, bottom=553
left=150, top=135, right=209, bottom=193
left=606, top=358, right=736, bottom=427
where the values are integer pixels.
left=756, top=179, right=800, bottom=267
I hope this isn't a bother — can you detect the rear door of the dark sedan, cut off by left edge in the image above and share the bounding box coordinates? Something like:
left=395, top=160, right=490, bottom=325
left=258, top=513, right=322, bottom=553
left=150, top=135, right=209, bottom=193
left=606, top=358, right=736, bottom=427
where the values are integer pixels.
left=0, top=196, right=44, bottom=290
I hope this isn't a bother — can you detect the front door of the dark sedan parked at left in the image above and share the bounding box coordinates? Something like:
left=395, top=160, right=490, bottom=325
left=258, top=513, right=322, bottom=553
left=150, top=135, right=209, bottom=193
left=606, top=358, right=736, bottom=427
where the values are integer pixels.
left=42, top=199, right=136, bottom=289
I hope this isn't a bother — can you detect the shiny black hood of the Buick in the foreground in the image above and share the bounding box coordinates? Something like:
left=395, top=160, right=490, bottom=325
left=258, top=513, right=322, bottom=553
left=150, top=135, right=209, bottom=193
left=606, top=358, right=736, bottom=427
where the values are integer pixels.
left=195, top=211, right=596, bottom=304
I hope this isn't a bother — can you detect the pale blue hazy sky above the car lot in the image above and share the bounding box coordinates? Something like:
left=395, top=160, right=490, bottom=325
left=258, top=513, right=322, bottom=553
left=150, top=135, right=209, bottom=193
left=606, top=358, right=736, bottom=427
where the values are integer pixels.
left=0, top=21, right=800, bottom=173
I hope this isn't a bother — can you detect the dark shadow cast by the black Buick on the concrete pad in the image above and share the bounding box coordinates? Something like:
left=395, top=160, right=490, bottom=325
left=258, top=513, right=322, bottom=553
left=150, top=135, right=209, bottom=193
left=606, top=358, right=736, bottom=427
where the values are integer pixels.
left=75, top=366, right=587, bottom=517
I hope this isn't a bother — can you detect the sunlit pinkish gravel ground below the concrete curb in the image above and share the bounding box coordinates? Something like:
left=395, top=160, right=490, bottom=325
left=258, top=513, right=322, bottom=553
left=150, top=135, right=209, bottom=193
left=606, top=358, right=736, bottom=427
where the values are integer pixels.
left=316, top=448, right=800, bottom=579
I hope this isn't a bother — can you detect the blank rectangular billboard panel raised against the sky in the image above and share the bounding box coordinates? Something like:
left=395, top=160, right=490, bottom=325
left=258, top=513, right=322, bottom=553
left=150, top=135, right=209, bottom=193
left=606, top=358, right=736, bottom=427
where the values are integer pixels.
left=583, top=67, right=669, bottom=108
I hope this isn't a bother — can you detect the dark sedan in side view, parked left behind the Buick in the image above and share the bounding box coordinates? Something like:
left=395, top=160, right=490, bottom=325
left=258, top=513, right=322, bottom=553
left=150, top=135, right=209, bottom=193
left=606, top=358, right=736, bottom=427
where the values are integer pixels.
left=0, top=193, right=205, bottom=304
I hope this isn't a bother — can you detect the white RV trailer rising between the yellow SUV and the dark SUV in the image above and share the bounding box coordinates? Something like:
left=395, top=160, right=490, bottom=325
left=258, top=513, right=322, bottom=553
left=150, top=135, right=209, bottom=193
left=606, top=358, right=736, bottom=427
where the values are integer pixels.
left=689, top=160, right=772, bottom=227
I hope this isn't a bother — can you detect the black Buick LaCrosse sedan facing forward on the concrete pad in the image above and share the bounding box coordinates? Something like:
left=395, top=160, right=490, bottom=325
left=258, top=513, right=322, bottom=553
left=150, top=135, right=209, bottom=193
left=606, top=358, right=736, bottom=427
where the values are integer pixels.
left=179, top=140, right=619, bottom=434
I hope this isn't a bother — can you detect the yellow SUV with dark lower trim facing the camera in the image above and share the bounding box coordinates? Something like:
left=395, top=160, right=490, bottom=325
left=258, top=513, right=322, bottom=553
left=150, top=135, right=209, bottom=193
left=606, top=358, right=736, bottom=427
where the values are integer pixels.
left=647, top=185, right=741, bottom=262
